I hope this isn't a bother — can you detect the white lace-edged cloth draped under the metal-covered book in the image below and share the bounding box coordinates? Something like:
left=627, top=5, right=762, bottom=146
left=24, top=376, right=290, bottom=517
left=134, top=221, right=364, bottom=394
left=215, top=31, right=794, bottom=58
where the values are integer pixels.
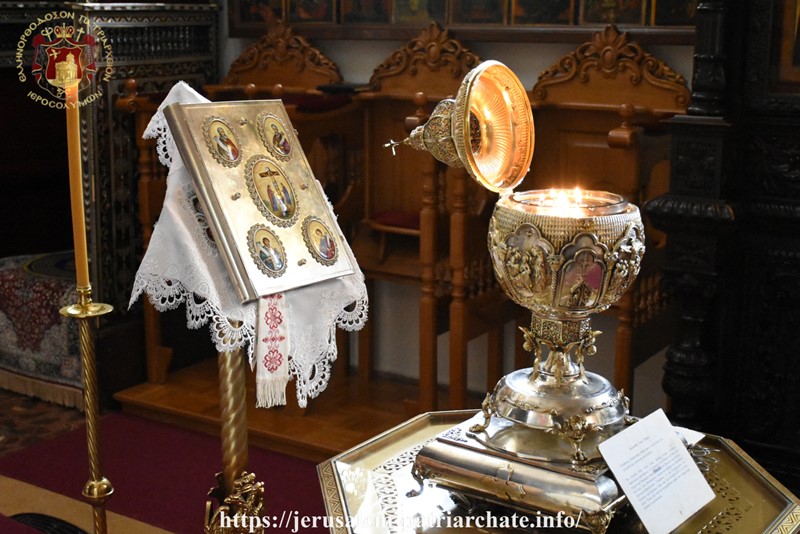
left=130, top=82, right=368, bottom=407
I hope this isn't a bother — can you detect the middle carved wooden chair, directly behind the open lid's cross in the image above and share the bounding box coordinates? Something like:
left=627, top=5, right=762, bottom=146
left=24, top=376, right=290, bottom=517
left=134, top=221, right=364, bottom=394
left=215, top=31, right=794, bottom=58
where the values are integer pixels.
left=354, top=23, right=521, bottom=411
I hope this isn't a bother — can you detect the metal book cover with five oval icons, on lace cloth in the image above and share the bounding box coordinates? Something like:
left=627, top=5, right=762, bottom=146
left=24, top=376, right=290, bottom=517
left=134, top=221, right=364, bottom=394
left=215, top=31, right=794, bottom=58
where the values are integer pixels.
left=164, top=100, right=355, bottom=302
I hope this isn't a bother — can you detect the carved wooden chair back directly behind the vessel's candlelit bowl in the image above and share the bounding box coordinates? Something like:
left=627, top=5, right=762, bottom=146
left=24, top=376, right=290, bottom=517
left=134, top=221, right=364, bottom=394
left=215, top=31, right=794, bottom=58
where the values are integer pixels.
left=527, top=26, right=689, bottom=206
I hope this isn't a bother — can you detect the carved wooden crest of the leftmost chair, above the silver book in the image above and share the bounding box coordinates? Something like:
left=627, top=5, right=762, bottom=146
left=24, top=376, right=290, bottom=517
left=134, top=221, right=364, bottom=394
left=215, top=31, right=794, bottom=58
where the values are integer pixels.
left=205, top=24, right=342, bottom=100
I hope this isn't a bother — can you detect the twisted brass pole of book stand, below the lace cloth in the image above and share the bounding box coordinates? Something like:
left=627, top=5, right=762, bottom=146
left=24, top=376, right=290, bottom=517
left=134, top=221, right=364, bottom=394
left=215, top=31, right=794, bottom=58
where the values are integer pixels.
left=217, top=348, right=247, bottom=495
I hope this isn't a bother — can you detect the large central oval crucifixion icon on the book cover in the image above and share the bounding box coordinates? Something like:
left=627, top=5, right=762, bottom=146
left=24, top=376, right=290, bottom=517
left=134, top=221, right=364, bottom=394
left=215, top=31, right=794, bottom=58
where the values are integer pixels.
left=245, top=156, right=298, bottom=228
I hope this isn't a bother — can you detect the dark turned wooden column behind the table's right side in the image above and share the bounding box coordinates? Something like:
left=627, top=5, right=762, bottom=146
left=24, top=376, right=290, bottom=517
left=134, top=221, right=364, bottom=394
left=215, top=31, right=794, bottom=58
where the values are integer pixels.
left=645, top=1, right=735, bottom=428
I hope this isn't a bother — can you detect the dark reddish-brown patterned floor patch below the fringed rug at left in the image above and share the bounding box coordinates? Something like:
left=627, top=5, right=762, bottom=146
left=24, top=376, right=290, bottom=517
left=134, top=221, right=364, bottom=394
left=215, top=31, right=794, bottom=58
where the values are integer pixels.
left=0, top=389, right=85, bottom=456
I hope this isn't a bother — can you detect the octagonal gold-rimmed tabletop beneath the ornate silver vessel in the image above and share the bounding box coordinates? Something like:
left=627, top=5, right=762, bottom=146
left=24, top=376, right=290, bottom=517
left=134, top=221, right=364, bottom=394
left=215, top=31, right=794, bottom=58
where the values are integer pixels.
left=317, top=410, right=800, bottom=534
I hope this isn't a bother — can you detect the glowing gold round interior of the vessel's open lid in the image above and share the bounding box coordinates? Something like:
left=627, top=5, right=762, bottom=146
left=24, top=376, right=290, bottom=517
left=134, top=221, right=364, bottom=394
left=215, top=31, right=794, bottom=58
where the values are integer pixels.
left=453, top=61, right=534, bottom=192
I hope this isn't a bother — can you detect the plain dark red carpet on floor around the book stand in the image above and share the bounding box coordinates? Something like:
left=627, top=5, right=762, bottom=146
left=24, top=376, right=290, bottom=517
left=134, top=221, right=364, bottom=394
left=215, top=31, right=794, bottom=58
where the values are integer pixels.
left=0, top=414, right=327, bottom=534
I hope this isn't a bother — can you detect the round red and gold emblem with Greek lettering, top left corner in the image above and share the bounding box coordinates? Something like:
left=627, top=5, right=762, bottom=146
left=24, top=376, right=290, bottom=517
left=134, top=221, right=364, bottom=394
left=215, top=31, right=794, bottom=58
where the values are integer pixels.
left=16, top=11, right=114, bottom=109
